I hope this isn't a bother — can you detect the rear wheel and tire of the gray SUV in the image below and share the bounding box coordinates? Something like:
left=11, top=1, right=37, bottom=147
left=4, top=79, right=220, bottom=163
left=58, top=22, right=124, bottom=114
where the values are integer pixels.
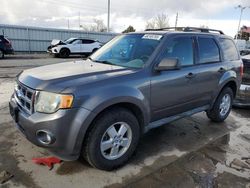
left=207, top=87, right=234, bottom=122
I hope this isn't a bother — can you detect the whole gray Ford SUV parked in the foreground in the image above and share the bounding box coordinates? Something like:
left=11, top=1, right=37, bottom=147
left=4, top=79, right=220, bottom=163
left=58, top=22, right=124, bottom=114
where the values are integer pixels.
left=9, top=27, right=243, bottom=170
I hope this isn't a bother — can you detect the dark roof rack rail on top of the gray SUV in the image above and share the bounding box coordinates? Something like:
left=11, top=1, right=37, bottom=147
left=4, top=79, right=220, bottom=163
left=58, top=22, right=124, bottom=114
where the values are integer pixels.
left=145, top=27, right=224, bottom=35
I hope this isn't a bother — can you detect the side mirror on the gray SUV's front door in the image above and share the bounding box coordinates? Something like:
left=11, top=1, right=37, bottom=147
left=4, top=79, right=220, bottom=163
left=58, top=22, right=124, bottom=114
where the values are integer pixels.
left=155, top=58, right=181, bottom=71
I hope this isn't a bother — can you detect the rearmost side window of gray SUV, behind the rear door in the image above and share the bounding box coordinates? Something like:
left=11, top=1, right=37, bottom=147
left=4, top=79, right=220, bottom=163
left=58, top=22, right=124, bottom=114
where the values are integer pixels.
left=220, top=39, right=239, bottom=61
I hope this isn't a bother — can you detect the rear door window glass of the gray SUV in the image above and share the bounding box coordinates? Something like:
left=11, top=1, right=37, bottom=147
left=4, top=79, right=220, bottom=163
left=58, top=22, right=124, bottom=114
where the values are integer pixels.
left=198, top=38, right=220, bottom=63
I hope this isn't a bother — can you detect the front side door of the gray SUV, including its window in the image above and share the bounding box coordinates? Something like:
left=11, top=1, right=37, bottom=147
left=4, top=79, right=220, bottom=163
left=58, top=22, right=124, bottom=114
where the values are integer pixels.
left=151, top=35, right=197, bottom=121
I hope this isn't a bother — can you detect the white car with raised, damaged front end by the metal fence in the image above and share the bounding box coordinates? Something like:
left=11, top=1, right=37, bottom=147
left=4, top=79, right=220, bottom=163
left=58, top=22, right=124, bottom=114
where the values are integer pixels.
left=47, top=38, right=103, bottom=58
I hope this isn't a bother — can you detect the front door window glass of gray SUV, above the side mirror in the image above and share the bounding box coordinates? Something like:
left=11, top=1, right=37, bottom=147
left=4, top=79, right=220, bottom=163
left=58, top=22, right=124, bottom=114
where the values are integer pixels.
left=163, top=37, right=194, bottom=66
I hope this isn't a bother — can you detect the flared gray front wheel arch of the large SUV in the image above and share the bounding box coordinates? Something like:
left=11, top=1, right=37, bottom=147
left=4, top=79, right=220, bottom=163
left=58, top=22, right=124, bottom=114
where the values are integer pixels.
left=74, top=86, right=150, bottom=156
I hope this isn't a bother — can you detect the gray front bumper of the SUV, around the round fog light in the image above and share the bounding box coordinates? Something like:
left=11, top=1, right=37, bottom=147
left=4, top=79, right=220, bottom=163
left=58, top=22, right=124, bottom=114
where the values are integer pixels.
left=9, top=98, right=92, bottom=161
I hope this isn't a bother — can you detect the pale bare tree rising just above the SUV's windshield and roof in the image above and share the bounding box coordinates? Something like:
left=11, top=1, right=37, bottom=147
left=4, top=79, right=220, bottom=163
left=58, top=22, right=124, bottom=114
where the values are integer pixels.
left=146, top=13, right=169, bottom=29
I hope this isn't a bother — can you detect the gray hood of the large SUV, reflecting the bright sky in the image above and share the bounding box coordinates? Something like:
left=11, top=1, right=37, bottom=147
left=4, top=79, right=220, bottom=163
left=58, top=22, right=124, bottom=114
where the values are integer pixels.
left=18, top=60, right=135, bottom=92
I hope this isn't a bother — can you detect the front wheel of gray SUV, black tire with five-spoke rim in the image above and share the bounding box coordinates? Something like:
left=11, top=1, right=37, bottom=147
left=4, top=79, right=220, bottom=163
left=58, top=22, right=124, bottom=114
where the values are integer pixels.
left=82, top=107, right=140, bottom=171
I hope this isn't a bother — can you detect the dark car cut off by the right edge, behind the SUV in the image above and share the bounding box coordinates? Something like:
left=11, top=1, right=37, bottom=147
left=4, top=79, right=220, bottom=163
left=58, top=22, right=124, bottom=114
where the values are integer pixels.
left=234, top=55, right=250, bottom=107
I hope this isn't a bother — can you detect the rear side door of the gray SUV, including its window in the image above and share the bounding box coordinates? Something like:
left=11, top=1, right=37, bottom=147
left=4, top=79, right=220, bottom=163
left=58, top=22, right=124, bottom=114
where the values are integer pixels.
left=189, top=35, right=227, bottom=106
